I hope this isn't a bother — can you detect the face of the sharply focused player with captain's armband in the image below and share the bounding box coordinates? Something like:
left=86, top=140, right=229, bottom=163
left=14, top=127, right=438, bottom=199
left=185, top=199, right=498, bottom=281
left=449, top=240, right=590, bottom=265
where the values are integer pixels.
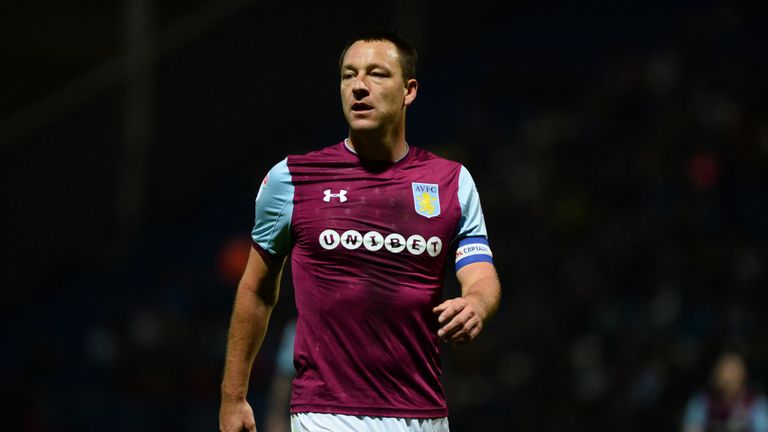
left=341, top=41, right=416, bottom=135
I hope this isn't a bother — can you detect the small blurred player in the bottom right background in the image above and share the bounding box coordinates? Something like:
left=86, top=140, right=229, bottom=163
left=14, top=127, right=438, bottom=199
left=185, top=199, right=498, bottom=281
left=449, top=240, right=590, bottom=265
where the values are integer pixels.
left=682, top=351, right=768, bottom=432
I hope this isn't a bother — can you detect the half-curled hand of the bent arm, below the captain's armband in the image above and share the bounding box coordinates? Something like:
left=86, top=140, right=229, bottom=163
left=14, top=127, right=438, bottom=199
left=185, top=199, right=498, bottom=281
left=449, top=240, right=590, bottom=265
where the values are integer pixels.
left=432, top=297, right=483, bottom=347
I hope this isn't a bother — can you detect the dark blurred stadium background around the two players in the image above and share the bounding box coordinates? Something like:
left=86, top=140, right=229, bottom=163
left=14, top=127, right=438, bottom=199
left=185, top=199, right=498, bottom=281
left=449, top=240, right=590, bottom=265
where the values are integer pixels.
left=0, top=0, right=768, bottom=432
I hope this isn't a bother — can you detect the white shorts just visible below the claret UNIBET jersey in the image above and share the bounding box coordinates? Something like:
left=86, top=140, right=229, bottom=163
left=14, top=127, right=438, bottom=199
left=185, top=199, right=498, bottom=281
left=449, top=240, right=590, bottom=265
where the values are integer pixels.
left=291, top=413, right=449, bottom=432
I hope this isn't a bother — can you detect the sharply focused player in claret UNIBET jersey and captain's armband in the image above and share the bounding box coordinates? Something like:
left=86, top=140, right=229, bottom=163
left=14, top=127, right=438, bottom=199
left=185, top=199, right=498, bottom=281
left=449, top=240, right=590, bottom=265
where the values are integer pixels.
left=220, top=32, right=501, bottom=432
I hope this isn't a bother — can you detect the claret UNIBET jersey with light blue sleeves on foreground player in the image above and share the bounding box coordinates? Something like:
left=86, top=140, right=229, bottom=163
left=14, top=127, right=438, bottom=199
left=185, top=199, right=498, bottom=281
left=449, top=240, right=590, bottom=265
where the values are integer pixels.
left=252, top=142, right=491, bottom=418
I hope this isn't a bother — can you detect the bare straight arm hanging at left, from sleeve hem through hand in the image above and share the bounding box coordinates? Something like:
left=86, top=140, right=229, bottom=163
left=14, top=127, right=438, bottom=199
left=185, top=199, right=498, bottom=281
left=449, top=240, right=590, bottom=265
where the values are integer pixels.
left=219, top=247, right=285, bottom=432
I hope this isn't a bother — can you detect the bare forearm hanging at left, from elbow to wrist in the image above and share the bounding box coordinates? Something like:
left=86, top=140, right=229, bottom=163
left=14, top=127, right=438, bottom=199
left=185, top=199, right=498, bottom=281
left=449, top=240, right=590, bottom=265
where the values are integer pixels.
left=221, top=286, right=274, bottom=400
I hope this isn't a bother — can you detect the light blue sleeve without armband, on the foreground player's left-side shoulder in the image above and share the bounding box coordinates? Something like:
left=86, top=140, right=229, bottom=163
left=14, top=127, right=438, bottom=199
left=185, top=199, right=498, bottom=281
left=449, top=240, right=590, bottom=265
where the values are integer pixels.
left=251, top=158, right=294, bottom=257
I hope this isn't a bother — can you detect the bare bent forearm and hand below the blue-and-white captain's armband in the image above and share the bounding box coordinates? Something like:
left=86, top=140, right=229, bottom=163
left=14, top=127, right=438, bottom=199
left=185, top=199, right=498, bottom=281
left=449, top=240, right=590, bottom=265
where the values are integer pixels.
left=432, top=262, right=501, bottom=346
